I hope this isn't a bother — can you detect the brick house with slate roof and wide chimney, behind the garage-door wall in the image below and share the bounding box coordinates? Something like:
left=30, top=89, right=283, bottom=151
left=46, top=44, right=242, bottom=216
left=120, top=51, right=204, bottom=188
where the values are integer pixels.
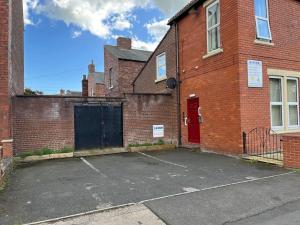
left=104, top=37, right=151, bottom=97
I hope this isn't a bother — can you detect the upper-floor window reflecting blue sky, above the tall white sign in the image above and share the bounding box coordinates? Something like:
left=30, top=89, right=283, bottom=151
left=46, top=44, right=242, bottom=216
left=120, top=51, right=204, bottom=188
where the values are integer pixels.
left=254, top=0, right=272, bottom=40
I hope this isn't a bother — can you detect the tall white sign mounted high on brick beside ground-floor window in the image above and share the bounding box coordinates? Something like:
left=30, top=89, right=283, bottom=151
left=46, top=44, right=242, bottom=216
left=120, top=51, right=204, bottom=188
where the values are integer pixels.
left=248, top=60, right=263, bottom=88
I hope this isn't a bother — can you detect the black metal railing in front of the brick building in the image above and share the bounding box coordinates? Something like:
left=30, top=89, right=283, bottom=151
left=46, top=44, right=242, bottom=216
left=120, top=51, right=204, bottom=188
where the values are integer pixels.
left=243, top=128, right=283, bottom=161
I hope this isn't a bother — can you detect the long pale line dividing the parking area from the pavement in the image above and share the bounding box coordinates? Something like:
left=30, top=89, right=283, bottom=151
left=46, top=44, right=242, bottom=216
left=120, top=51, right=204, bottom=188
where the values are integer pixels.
left=24, top=171, right=296, bottom=225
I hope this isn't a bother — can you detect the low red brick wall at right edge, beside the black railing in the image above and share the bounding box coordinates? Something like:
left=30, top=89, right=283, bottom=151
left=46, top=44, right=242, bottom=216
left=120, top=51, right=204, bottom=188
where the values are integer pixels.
left=283, top=134, right=300, bottom=168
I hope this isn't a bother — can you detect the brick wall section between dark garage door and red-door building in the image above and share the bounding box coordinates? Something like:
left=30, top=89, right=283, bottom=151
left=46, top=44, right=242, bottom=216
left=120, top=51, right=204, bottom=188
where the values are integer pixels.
left=123, top=94, right=178, bottom=146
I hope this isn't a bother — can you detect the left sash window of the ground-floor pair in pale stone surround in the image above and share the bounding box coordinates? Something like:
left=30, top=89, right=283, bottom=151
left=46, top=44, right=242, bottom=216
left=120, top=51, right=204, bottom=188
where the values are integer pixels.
left=270, top=77, right=284, bottom=130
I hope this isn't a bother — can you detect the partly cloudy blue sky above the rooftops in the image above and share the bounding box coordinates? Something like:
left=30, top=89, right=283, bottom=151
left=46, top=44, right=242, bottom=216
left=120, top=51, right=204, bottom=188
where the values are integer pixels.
left=23, top=0, right=189, bottom=94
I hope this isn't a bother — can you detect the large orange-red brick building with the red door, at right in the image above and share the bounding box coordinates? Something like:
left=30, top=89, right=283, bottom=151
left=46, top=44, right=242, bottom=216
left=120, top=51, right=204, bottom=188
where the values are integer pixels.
left=169, top=0, right=300, bottom=154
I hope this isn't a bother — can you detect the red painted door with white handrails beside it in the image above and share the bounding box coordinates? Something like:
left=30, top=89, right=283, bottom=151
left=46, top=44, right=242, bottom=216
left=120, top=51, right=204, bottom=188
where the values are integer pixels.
left=187, top=98, right=200, bottom=144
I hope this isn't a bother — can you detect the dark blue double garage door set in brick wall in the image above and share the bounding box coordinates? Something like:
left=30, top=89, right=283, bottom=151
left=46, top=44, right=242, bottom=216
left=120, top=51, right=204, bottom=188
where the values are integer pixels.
left=74, top=105, right=123, bottom=150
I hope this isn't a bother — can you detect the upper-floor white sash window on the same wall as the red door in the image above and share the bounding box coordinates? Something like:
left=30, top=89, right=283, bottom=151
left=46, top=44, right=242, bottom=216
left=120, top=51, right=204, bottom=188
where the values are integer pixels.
left=206, top=1, right=221, bottom=52
